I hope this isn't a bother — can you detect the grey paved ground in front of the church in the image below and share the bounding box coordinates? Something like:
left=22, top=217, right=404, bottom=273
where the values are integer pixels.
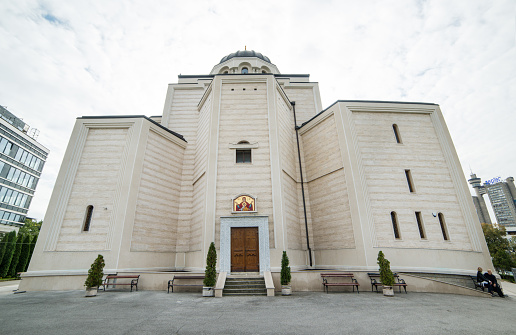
left=0, top=283, right=516, bottom=335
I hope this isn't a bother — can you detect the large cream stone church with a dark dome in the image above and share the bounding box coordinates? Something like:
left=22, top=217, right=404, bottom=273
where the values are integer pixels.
left=20, top=51, right=492, bottom=290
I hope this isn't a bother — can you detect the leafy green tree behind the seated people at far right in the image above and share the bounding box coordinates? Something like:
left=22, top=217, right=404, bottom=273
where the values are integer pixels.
left=482, top=223, right=516, bottom=273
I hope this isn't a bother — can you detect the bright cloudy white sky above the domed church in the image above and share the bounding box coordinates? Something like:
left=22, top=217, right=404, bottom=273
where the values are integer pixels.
left=0, top=0, right=516, bottom=220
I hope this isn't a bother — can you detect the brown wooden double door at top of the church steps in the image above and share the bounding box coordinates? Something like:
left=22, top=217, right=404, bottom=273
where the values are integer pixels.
left=231, top=227, right=260, bottom=272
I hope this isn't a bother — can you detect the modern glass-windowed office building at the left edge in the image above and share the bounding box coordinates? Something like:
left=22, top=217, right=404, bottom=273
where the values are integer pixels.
left=0, top=106, right=49, bottom=238
